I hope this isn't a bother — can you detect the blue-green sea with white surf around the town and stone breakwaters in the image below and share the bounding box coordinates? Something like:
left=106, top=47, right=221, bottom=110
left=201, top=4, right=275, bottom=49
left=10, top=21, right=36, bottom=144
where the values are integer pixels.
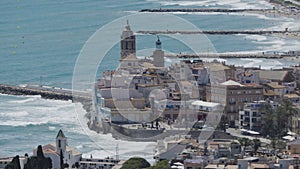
left=0, top=0, right=300, bottom=162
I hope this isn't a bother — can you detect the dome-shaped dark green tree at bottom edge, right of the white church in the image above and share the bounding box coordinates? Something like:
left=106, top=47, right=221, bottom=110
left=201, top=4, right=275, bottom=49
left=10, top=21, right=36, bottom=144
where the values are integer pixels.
left=121, top=157, right=150, bottom=169
